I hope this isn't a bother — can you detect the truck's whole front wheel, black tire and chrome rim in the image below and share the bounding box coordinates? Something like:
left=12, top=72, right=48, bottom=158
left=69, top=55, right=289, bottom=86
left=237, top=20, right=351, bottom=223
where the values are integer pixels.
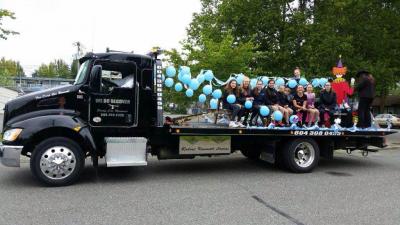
left=30, top=137, right=85, bottom=186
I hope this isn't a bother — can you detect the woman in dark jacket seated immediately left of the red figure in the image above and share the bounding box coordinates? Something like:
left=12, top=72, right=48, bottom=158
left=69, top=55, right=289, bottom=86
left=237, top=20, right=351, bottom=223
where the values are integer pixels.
left=318, top=82, right=336, bottom=127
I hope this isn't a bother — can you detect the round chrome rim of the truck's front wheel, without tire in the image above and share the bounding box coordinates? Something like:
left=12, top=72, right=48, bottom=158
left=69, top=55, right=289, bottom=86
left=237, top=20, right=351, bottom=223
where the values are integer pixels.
left=40, top=146, right=76, bottom=180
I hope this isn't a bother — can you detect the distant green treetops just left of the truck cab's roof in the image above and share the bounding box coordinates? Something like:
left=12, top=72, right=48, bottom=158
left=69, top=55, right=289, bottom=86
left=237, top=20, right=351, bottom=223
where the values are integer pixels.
left=34, top=59, right=75, bottom=78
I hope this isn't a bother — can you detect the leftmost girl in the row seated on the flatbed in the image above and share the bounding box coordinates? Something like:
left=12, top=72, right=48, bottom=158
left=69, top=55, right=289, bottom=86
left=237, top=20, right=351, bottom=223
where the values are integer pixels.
left=222, top=79, right=245, bottom=127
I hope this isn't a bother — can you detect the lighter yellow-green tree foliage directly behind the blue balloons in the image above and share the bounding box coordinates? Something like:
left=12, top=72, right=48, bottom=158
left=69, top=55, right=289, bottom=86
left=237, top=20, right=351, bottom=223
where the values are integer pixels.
left=163, top=33, right=255, bottom=110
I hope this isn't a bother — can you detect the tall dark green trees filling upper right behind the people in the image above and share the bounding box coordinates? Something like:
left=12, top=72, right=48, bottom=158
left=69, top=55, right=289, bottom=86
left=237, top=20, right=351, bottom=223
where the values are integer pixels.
left=184, top=0, right=400, bottom=93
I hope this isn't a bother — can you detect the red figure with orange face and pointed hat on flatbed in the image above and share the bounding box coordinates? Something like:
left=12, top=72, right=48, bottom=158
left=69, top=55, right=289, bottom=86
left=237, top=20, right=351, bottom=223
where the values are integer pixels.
left=332, top=56, right=353, bottom=106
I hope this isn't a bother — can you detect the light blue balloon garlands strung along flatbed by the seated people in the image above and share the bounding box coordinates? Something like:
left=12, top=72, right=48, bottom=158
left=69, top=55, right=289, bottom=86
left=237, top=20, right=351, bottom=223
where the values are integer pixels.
left=163, top=66, right=328, bottom=117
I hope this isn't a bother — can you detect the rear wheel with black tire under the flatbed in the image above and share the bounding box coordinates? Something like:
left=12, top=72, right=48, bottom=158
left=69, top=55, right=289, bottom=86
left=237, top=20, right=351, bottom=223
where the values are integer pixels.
left=283, top=138, right=320, bottom=173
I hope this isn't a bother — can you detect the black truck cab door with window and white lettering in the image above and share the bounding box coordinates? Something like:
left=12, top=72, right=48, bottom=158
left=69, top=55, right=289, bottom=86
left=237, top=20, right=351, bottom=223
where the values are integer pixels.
left=89, top=60, right=139, bottom=128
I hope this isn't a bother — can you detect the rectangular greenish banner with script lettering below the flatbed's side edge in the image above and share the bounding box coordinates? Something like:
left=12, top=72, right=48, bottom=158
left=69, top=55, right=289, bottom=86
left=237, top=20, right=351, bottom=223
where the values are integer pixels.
left=179, top=136, right=231, bottom=155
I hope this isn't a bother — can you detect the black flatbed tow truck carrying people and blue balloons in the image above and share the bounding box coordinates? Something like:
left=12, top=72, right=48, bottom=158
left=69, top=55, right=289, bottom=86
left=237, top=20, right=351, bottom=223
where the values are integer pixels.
left=0, top=52, right=393, bottom=186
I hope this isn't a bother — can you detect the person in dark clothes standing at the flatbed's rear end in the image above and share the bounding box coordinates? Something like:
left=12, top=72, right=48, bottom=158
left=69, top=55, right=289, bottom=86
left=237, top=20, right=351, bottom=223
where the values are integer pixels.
left=355, top=71, right=375, bottom=128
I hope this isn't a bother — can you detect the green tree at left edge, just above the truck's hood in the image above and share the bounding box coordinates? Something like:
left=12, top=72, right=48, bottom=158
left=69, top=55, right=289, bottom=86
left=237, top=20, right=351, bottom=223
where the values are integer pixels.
left=0, top=57, right=25, bottom=86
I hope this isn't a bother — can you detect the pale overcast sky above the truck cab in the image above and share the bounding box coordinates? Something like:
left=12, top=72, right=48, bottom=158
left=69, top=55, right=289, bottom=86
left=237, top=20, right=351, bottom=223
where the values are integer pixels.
left=0, top=0, right=201, bottom=74
